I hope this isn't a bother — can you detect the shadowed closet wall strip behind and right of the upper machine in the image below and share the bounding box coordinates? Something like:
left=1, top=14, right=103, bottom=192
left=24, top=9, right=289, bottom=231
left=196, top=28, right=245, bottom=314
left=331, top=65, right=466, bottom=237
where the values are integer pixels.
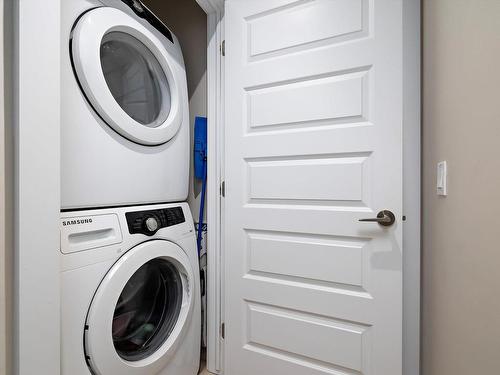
left=143, top=0, right=207, bottom=222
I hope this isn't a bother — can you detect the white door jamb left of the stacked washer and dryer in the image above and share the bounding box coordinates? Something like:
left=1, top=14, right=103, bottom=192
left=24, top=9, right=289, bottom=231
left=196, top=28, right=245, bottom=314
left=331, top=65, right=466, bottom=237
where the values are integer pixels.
left=14, top=0, right=63, bottom=375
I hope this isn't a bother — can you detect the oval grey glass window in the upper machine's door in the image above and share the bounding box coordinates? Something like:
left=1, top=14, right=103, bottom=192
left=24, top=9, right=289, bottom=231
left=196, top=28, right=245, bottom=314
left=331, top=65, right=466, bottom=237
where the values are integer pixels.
left=100, top=31, right=171, bottom=128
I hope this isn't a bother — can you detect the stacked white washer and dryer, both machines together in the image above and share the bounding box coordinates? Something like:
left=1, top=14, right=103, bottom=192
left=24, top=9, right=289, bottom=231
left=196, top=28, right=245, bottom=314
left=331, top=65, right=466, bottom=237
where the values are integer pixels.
left=60, top=0, right=200, bottom=375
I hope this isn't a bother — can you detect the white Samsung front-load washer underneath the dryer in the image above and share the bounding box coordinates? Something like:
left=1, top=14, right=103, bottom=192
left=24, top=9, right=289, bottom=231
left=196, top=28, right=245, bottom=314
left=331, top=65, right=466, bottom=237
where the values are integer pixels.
left=61, top=203, right=201, bottom=375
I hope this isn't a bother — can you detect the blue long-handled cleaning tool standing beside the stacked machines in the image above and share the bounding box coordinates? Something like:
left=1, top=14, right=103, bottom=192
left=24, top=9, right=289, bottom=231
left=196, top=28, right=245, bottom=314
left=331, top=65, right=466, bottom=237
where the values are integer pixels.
left=194, top=117, right=207, bottom=255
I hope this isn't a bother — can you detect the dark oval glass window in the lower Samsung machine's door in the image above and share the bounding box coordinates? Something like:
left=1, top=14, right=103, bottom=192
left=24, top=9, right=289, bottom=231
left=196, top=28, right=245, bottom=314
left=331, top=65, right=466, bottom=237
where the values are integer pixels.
left=112, top=258, right=183, bottom=361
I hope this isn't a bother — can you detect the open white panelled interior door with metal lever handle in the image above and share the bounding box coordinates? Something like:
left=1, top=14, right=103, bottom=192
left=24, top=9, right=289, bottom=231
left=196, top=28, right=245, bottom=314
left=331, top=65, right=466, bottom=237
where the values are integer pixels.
left=225, top=0, right=403, bottom=375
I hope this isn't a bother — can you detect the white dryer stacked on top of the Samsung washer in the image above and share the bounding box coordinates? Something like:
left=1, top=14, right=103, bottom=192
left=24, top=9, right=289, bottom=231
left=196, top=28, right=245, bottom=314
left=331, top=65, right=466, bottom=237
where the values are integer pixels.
left=61, top=0, right=190, bottom=209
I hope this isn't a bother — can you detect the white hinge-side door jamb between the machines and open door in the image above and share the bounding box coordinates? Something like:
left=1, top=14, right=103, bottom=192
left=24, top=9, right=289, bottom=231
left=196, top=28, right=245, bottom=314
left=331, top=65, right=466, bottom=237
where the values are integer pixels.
left=196, top=0, right=224, bottom=374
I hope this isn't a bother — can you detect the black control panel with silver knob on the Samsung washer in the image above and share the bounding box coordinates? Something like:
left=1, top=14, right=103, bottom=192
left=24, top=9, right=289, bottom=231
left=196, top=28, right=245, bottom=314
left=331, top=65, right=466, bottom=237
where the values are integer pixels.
left=125, top=207, right=186, bottom=236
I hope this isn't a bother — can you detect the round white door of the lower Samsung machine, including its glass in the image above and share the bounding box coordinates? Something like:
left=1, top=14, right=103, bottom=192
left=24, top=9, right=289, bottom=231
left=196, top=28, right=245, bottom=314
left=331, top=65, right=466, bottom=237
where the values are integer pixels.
left=84, top=240, right=196, bottom=375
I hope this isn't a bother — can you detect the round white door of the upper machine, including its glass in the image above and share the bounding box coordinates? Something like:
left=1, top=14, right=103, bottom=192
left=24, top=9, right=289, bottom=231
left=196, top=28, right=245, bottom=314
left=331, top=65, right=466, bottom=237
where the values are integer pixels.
left=71, top=7, right=187, bottom=146
